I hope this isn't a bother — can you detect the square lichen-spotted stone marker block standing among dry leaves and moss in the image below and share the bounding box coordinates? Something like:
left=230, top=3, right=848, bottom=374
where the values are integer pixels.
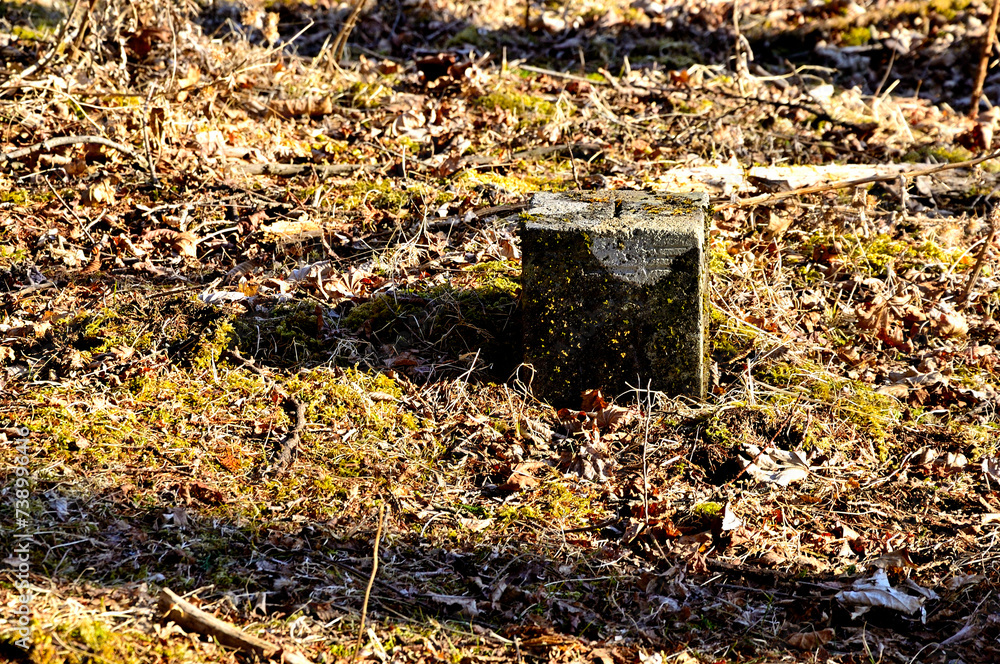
left=521, top=191, right=708, bottom=407
